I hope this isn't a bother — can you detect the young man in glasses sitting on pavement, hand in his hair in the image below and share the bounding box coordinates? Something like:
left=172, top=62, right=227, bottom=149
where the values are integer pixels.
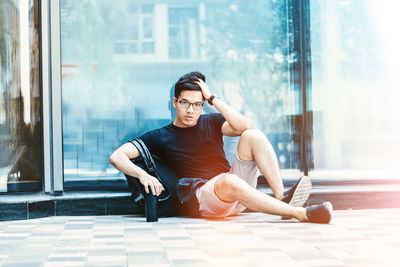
left=110, top=72, right=332, bottom=223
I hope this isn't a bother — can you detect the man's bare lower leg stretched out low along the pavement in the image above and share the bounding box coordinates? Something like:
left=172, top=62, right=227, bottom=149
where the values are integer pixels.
left=214, top=174, right=307, bottom=222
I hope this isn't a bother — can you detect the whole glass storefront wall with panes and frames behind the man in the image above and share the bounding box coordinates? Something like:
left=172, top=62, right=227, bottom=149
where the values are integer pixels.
left=0, top=0, right=400, bottom=197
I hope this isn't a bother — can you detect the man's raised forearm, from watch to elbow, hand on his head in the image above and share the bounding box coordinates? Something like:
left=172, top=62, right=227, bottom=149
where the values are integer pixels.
left=212, top=98, right=251, bottom=132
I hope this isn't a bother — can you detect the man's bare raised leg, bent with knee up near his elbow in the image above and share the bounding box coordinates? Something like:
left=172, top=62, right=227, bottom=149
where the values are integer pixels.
left=237, top=129, right=283, bottom=200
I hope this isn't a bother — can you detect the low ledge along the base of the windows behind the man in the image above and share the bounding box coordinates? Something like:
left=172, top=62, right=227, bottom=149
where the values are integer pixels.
left=0, top=183, right=400, bottom=221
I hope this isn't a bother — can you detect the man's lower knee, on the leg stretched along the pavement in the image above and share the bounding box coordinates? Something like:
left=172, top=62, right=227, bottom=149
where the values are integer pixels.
left=214, top=173, right=243, bottom=202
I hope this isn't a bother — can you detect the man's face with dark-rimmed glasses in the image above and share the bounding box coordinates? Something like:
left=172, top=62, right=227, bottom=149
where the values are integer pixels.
left=173, top=90, right=204, bottom=128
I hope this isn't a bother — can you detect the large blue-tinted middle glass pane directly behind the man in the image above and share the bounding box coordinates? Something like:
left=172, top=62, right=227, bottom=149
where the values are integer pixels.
left=61, top=0, right=298, bottom=188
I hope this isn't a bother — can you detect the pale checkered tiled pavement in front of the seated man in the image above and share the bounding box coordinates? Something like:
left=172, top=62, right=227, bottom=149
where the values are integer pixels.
left=0, top=209, right=400, bottom=267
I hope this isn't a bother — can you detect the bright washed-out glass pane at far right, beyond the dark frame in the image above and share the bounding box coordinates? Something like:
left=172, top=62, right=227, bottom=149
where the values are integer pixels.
left=311, top=0, right=400, bottom=179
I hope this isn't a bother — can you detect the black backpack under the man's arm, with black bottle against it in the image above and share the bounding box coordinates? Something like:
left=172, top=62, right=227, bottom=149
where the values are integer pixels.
left=125, top=138, right=180, bottom=222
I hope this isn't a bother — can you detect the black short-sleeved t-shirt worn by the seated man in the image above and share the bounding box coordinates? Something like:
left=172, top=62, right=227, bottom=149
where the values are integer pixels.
left=134, top=113, right=230, bottom=179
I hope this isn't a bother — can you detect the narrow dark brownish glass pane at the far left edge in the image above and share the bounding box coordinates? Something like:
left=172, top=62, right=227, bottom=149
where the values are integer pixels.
left=0, top=0, right=43, bottom=192
